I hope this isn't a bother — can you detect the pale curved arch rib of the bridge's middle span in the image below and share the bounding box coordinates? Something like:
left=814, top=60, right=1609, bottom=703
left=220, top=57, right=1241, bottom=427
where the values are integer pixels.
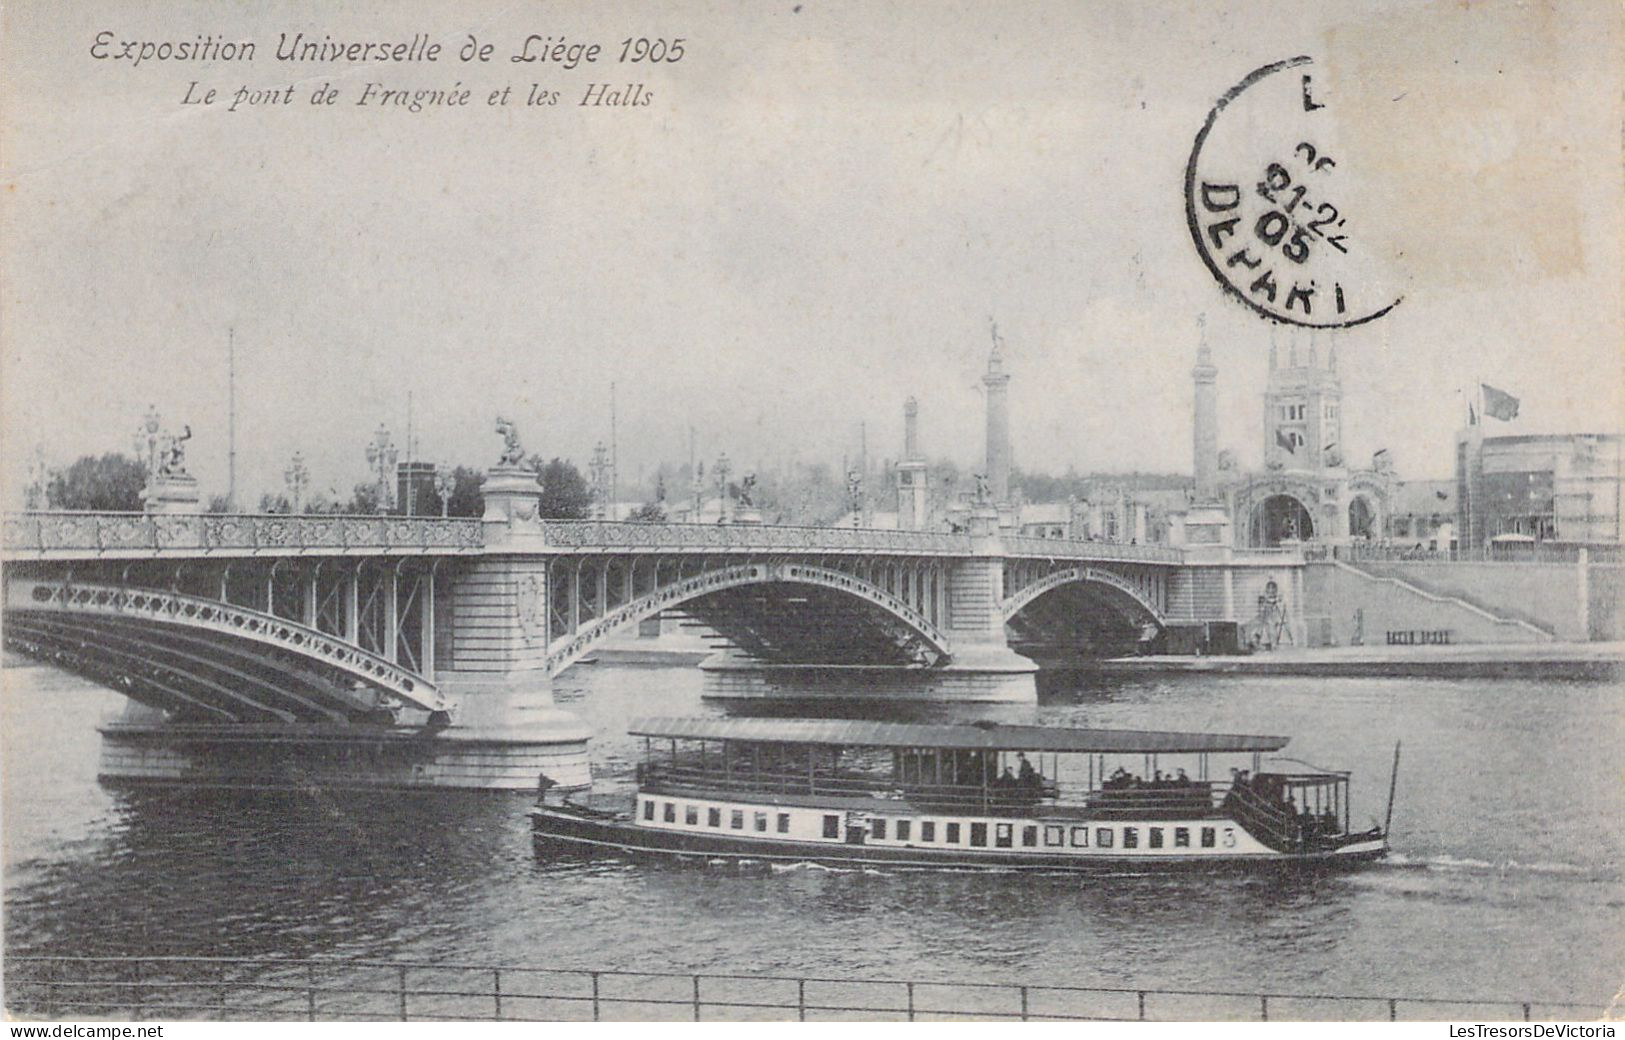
left=546, top=562, right=952, bottom=676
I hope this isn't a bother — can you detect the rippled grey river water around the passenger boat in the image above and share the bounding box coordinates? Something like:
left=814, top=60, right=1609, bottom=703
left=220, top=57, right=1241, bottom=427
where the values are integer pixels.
left=0, top=666, right=1625, bottom=1004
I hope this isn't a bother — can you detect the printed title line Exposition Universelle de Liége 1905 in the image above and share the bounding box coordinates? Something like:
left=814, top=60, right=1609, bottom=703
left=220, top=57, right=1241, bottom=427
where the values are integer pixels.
left=91, top=31, right=686, bottom=70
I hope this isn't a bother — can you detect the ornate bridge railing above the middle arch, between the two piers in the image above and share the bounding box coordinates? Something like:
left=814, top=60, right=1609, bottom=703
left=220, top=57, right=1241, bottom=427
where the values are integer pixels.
left=541, top=520, right=972, bottom=556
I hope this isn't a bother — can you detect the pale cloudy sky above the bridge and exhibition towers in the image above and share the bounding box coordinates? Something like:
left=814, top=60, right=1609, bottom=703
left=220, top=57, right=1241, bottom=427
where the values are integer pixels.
left=0, top=0, right=1625, bottom=505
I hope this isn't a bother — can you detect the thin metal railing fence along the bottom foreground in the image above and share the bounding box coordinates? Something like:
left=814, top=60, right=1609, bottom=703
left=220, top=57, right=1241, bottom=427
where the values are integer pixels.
left=5, top=957, right=1609, bottom=1022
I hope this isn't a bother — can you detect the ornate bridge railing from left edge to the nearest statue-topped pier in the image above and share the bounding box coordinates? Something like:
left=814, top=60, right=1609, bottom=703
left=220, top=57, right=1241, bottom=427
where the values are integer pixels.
left=0, top=512, right=484, bottom=559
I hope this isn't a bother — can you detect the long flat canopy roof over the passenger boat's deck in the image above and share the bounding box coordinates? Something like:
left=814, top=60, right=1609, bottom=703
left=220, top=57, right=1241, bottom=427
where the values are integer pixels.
left=627, top=718, right=1290, bottom=754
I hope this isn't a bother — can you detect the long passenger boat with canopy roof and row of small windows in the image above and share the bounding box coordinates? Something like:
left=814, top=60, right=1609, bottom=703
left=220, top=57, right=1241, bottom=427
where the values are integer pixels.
left=531, top=718, right=1399, bottom=871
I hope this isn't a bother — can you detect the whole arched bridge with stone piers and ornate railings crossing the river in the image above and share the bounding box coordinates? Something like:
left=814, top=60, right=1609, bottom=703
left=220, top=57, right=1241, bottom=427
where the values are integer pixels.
left=3, top=466, right=1302, bottom=791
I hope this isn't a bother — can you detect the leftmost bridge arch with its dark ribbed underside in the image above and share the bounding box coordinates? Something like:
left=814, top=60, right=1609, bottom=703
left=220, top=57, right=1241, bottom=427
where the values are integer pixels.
left=5, top=579, right=452, bottom=722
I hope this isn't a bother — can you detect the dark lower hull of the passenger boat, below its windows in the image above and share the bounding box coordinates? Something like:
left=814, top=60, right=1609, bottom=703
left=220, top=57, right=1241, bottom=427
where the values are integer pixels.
left=531, top=806, right=1388, bottom=873
